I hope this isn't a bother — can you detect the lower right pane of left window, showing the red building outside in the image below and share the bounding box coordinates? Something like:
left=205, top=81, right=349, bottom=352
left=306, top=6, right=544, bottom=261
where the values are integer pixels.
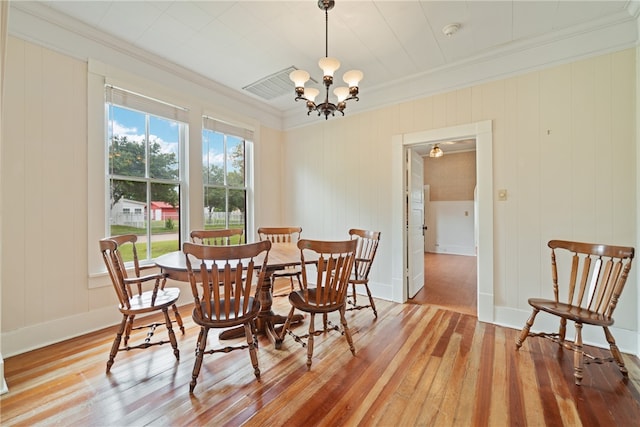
left=150, top=183, right=180, bottom=258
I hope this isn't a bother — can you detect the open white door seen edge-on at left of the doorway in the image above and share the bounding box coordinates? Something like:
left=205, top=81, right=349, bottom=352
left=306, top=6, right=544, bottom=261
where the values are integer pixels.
left=406, top=149, right=424, bottom=298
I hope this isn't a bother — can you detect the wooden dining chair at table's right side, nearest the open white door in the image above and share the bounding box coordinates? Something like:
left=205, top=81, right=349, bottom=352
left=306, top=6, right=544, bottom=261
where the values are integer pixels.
left=347, top=228, right=380, bottom=317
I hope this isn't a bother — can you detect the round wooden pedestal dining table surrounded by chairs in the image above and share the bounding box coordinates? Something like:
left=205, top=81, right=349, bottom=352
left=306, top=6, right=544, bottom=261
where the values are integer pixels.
left=154, top=243, right=308, bottom=349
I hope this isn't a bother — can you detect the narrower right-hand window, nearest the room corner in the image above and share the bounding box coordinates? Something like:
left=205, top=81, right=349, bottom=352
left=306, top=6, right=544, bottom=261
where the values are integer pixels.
left=202, top=117, right=253, bottom=241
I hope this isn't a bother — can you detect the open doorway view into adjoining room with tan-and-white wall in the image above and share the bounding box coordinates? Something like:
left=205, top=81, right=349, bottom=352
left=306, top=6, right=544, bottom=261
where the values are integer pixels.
left=410, top=144, right=478, bottom=316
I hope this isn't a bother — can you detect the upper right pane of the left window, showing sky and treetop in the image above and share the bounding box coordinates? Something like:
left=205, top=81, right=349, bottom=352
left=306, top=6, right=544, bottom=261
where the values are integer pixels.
left=149, top=116, right=180, bottom=180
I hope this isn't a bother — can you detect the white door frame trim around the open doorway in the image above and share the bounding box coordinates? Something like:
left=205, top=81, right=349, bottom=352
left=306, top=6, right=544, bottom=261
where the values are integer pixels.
left=391, top=120, right=494, bottom=322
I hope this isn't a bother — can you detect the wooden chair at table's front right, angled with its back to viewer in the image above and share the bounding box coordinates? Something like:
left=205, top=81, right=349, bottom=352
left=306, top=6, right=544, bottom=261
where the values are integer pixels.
left=281, top=239, right=358, bottom=370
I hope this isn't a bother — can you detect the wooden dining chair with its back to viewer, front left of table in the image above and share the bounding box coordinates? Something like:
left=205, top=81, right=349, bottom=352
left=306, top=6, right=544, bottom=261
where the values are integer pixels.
left=182, top=241, right=271, bottom=393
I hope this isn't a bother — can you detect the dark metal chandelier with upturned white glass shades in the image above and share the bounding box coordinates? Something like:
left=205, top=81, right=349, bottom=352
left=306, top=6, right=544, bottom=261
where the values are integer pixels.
left=289, top=0, right=363, bottom=120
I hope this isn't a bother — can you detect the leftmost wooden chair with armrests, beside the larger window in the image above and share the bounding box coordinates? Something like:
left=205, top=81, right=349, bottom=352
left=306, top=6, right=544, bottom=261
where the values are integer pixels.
left=100, top=234, right=184, bottom=373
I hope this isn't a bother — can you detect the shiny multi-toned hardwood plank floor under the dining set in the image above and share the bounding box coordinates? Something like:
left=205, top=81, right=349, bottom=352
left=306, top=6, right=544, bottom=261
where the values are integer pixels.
left=0, top=281, right=640, bottom=426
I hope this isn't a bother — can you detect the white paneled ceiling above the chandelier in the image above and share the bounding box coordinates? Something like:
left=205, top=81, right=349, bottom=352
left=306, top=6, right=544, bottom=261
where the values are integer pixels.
left=10, top=0, right=638, bottom=128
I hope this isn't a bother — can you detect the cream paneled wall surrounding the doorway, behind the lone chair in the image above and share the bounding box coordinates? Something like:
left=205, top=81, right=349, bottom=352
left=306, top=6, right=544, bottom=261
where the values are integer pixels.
left=283, top=49, right=638, bottom=344
